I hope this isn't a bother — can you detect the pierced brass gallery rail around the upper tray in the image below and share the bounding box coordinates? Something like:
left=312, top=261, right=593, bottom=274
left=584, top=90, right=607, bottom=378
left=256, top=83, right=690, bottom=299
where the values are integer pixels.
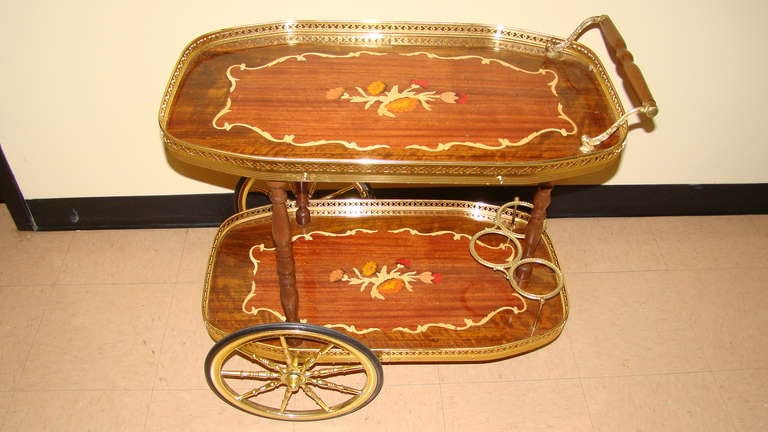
left=159, top=21, right=628, bottom=185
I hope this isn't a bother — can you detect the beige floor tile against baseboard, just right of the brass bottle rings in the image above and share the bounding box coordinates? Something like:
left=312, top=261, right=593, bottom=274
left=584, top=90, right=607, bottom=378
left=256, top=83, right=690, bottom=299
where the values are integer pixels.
left=548, top=218, right=665, bottom=273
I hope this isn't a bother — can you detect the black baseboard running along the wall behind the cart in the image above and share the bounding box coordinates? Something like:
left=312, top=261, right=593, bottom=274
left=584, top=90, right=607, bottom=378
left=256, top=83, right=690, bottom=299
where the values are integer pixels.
left=17, top=183, right=768, bottom=231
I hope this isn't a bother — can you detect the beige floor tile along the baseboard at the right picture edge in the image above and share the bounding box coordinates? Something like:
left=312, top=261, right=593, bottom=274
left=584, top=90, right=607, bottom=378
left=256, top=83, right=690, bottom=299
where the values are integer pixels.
left=654, top=216, right=768, bottom=269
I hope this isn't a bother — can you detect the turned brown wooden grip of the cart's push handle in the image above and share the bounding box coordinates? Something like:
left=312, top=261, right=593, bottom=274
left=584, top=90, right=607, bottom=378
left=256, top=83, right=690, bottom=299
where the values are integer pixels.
left=597, top=15, right=659, bottom=117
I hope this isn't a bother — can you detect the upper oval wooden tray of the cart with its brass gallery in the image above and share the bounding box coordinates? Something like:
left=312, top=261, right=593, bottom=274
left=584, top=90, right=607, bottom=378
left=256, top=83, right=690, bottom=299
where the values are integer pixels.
left=160, top=17, right=656, bottom=184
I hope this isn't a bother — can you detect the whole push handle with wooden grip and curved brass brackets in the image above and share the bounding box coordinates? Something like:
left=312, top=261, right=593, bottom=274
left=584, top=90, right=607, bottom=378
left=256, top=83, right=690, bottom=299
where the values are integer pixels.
left=547, top=15, right=659, bottom=153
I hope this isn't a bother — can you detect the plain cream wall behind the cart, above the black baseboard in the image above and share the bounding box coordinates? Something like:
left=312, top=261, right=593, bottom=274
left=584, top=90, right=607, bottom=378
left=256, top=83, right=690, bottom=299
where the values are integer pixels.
left=0, top=0, right=768, bottom=198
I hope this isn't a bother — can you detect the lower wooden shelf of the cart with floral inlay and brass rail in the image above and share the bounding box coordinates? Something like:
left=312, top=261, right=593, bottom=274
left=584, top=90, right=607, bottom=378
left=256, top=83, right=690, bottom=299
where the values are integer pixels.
left=203, top=200, right=567, bottom=362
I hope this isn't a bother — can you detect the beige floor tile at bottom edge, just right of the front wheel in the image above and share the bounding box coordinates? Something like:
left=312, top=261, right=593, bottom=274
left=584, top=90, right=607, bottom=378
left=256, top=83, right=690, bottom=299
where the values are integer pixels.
left=294, top=383, right=445, bottom=432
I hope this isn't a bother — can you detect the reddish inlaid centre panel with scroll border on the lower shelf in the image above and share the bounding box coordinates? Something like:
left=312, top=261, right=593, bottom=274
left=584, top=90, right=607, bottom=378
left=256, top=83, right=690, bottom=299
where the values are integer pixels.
left=242, top=228, right=527, bottom=334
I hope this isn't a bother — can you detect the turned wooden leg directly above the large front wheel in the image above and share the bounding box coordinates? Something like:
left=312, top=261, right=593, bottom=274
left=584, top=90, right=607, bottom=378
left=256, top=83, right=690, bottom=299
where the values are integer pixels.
left=267, top=182, right=299, bottom=322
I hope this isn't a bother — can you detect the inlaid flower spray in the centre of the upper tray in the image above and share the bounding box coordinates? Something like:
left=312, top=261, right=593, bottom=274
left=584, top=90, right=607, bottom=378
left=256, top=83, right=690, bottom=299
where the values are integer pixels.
left=325, top=79, right=468, bottom=118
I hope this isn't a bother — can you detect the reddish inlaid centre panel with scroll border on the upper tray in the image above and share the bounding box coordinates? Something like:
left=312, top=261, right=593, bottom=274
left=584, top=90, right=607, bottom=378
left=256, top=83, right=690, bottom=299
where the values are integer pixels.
left=212, top=51, right=577, bottom=152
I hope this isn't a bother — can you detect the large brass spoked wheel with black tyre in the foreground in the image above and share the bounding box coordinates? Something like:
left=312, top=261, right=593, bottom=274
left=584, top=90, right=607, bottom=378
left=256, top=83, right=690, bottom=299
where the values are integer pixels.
left=205, top=323, right=383, bottom=421
